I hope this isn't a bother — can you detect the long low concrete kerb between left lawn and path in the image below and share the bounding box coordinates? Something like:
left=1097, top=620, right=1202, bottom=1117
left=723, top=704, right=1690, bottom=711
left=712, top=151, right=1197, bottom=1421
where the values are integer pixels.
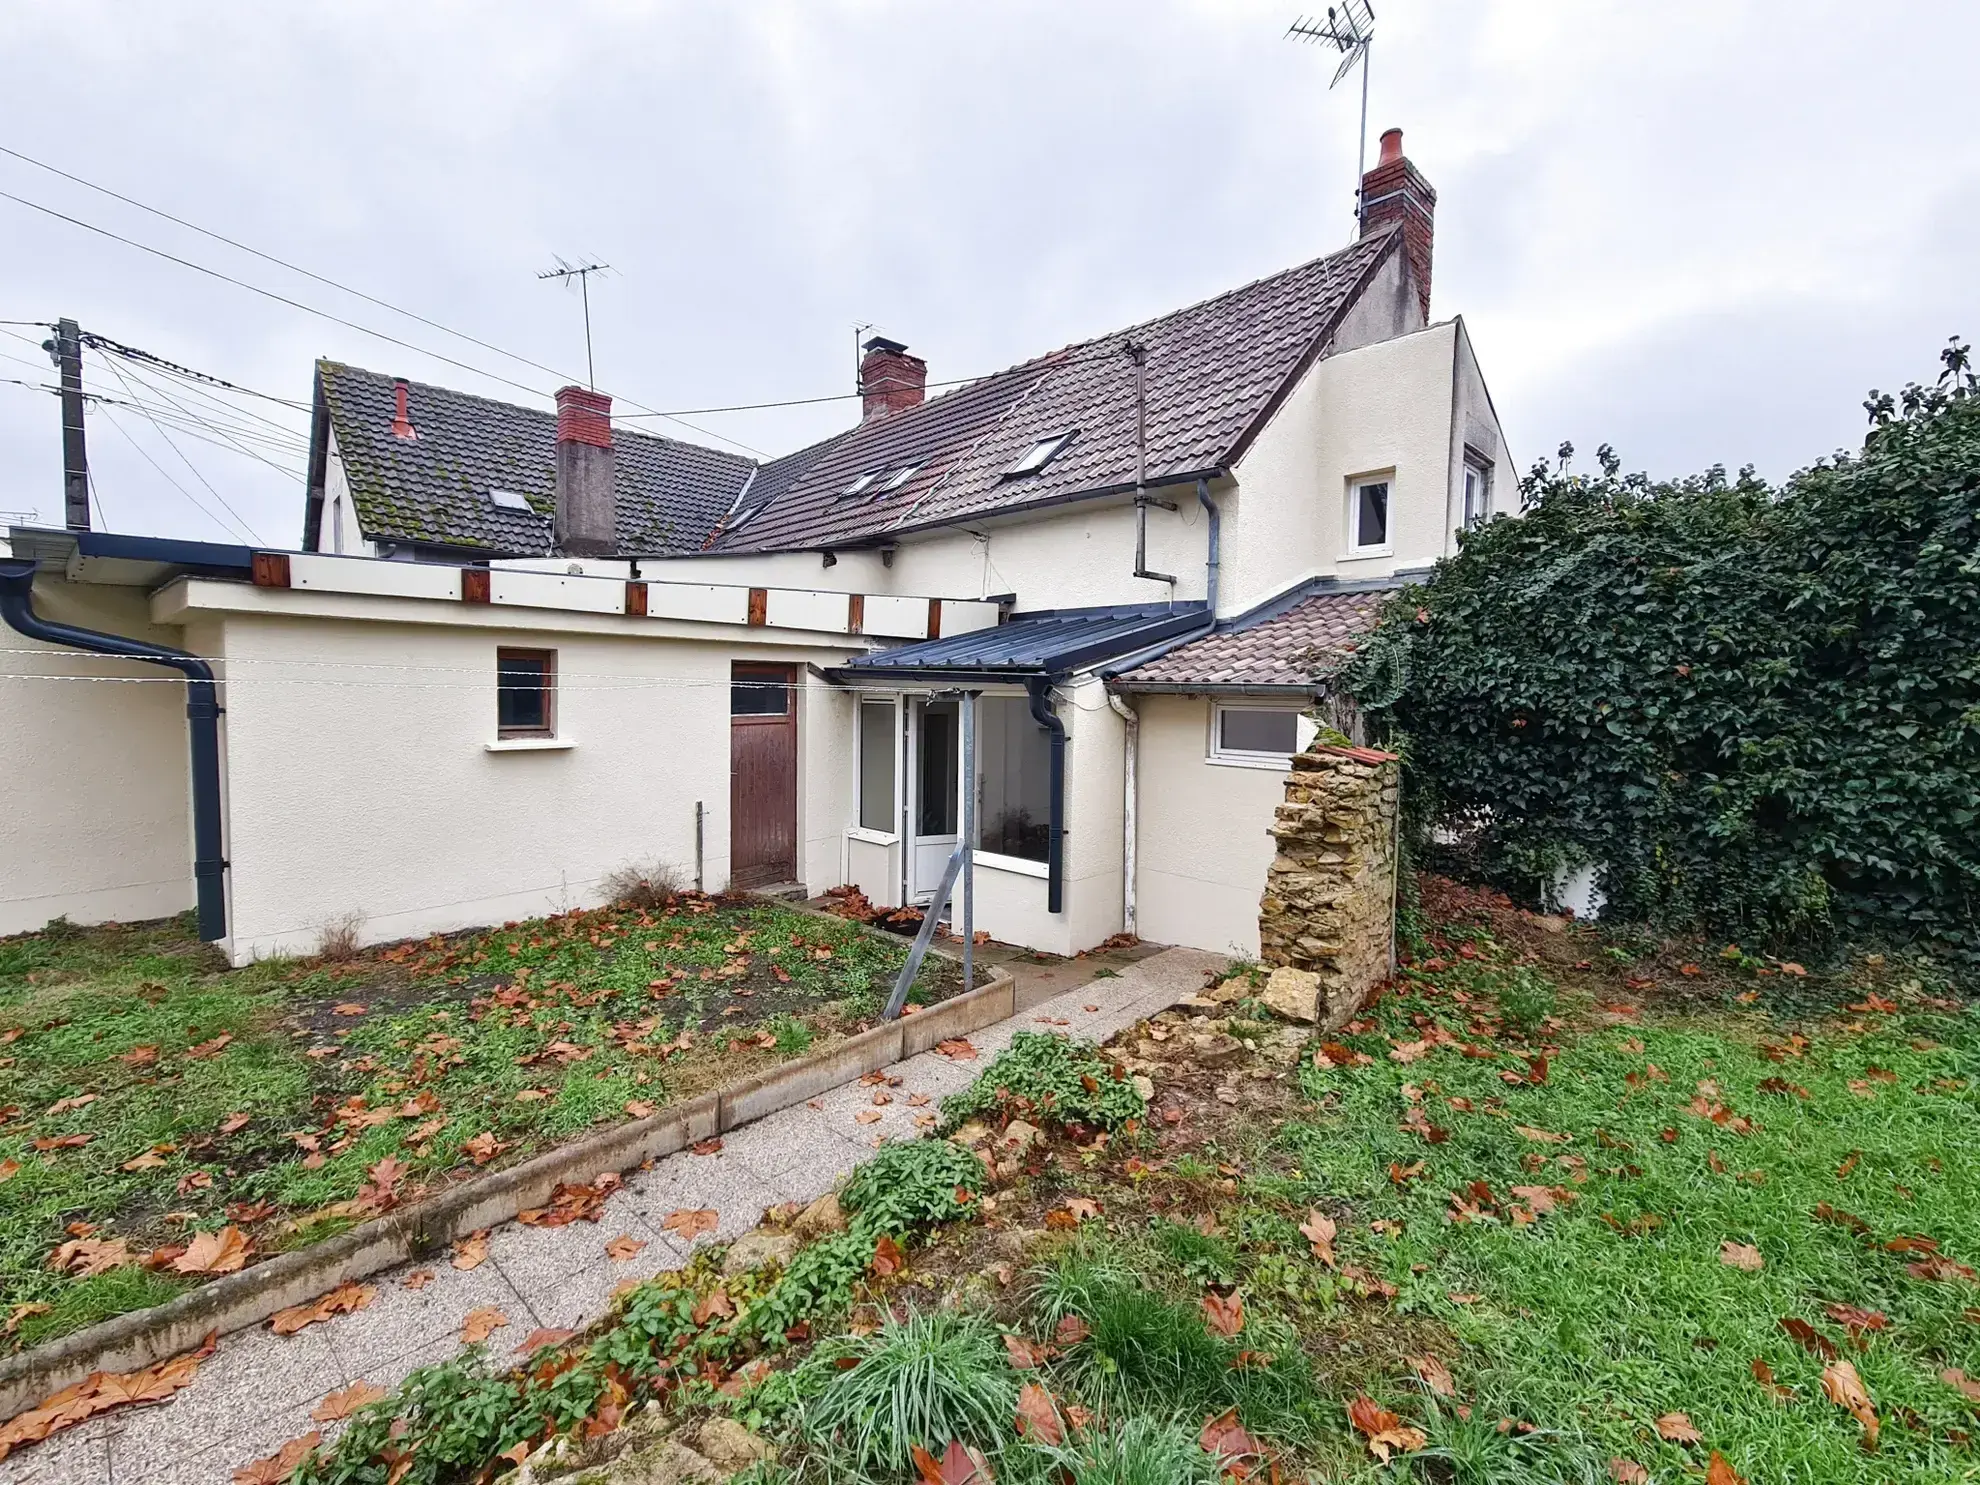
left=0, top=966, right=1020, bottom=1422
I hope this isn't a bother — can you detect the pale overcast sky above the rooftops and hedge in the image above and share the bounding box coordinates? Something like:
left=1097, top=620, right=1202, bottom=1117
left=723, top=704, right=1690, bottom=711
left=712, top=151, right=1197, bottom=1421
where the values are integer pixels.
left=0, top=0, right=1980, bottom=545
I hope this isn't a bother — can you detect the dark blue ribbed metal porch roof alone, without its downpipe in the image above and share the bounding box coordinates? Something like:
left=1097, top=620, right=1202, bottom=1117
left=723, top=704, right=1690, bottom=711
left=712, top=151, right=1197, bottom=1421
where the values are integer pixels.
left=832, top=602, right=1206, bottom=685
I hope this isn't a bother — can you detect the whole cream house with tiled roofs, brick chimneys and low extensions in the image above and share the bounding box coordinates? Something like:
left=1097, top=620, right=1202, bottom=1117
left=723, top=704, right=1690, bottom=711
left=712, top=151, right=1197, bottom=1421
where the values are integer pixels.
left=0, top=131, right=1513, bottom=962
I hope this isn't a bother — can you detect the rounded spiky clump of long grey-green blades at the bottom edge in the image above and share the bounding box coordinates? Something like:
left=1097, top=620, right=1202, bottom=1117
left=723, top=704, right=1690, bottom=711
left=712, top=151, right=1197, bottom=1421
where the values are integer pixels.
left=800, top=1311, right=1018, bottom=1481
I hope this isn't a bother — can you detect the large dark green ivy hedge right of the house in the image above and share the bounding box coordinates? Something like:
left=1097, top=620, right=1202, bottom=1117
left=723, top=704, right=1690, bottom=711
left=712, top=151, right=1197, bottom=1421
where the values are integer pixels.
left=1335, top=341, right=1980, bottom=960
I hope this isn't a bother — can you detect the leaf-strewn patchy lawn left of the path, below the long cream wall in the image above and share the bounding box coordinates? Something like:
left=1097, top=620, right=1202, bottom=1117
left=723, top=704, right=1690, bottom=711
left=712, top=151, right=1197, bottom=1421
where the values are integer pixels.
left=0, top=897, right=958, bottom=1348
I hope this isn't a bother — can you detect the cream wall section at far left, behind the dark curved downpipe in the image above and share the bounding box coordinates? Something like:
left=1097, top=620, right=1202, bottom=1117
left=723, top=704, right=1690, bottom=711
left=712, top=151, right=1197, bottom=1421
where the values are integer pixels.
left=0, top=578, right=192, bottom=935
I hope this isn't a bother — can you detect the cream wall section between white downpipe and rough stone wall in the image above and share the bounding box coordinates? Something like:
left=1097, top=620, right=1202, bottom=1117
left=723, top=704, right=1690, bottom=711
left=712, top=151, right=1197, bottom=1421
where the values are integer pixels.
left=1135, top=695, right=1285, bottom=958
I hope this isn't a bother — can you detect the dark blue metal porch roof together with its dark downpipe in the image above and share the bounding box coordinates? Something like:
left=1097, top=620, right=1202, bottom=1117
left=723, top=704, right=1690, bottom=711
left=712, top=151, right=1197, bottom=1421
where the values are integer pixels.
left=826, top=602, right=1210, bottom=913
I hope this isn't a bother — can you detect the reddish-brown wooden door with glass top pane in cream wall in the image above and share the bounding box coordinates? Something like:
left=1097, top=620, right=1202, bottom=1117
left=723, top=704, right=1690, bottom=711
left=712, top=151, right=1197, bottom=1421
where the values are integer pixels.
left=729, top=663, right=798, bottom=887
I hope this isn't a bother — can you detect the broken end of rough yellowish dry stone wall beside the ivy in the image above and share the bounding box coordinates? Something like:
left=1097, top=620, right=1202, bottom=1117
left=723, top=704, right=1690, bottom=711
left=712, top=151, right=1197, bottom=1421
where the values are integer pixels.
left=1259, top=746, right=1400, bottom=1028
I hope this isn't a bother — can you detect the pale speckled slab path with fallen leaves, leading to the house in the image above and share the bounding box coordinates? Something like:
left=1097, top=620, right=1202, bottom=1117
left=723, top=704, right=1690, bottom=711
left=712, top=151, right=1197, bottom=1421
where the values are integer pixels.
left=0, top=948, right=1226, bottom=1485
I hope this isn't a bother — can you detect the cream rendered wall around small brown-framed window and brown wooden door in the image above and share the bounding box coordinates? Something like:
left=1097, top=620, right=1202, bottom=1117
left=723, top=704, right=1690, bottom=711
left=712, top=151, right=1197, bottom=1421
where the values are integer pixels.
left=224, top=614, right=847, bottom=962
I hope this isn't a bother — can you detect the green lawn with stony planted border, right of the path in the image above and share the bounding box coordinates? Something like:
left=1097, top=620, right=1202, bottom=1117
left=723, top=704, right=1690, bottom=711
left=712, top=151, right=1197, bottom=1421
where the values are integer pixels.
left=15, top=881, right=1980, bottom=1485
